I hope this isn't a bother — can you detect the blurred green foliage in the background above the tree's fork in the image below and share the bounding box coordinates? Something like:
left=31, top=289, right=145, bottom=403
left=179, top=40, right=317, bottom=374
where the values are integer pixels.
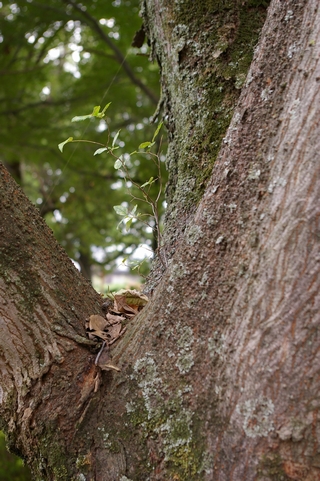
left=0, top=0, right=166, bottom=277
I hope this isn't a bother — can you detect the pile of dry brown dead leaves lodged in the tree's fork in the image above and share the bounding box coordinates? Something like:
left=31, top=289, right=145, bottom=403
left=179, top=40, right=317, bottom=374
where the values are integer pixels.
left=85, top=289, right=148, bottom=370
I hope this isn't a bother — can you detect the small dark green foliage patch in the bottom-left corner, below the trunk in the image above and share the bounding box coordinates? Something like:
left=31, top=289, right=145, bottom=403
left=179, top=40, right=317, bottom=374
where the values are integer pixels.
left=0, top=431, right=32, bottom=481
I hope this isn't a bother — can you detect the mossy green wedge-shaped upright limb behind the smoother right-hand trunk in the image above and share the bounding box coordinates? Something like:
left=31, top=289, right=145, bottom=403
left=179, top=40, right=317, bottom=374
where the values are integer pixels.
left=142, top=0, right=269, bottom=266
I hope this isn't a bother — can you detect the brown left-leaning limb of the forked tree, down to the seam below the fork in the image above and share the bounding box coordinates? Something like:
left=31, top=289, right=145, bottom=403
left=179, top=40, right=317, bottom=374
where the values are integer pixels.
left=0, top=166, right=101, bottom=479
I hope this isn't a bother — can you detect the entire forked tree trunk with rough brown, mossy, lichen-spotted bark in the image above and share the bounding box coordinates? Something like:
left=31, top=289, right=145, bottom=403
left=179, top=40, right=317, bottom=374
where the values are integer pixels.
left=0, top=0, right=320, bottom=481
